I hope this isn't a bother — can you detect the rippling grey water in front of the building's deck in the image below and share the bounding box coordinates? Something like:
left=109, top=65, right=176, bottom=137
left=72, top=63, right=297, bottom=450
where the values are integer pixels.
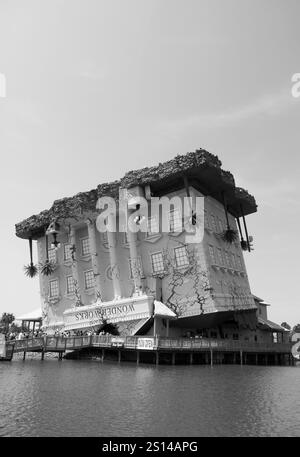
left=0, top=359, right=300, bottom=437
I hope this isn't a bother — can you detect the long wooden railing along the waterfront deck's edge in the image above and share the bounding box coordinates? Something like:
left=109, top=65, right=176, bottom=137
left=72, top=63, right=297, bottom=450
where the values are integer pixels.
left=10, top=335, right=291, bottom=353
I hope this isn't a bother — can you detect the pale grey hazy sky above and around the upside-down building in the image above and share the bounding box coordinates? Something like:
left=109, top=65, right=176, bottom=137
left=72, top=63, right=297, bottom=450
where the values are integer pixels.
left=0, top=0, right=300, bottom=325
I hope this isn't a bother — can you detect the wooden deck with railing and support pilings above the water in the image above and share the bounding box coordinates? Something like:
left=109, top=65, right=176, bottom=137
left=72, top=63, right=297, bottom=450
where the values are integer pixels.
left=9, top=335, right=291, bottom=364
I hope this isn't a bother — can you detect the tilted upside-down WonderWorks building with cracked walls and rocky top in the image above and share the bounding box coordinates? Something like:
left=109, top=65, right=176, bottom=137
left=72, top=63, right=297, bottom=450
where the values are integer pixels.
left=16, top=149, right=284, bottom=342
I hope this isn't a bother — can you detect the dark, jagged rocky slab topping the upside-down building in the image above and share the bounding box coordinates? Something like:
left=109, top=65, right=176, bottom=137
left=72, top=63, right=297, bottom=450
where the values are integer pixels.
left=16, top=149, right=257, bottom=238
